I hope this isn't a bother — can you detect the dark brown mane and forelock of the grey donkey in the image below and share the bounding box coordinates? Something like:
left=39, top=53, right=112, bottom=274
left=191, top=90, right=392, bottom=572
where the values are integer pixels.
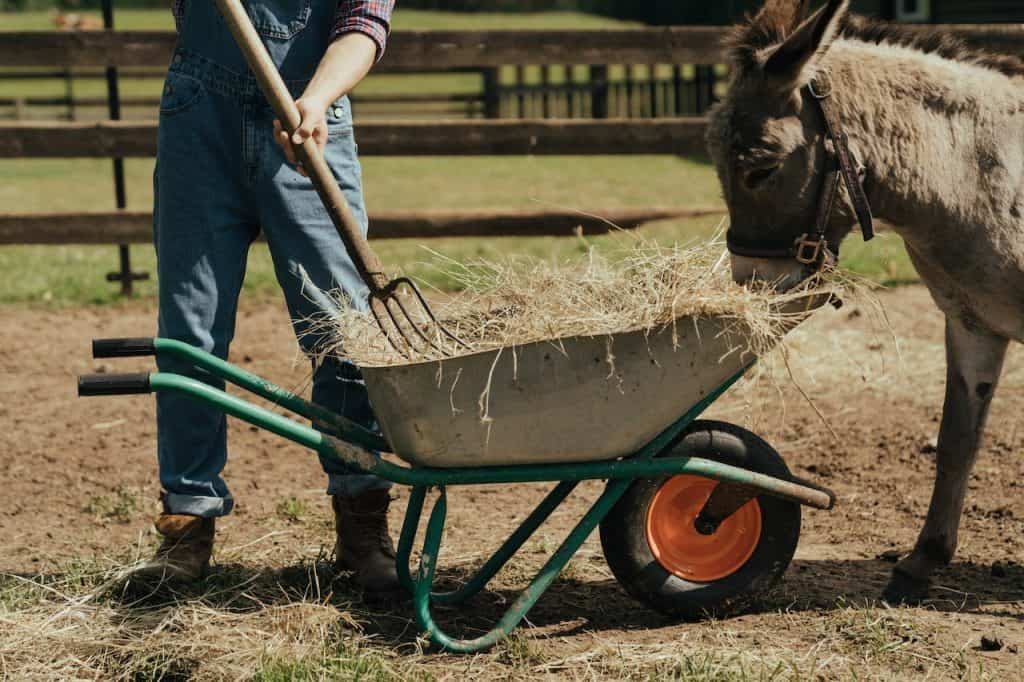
left=725, top=9, right=1024, bottom=78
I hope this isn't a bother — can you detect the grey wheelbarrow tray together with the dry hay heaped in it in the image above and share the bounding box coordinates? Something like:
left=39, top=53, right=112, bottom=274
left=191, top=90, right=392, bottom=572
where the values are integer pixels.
left=301, top=235, right=845, bottom=467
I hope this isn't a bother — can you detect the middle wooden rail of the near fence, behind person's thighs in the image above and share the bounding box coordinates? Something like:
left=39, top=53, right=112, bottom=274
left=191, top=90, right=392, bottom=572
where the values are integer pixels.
left=0, top=118, right=707, bottom=159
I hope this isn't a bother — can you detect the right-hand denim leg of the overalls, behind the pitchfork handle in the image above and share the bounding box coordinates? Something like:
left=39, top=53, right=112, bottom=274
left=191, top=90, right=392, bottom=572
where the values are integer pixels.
left=260, top=99, right=390, bottom=497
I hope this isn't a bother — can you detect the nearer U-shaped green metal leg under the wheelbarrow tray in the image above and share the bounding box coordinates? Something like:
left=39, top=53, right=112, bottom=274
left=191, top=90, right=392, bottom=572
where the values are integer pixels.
left=413, top=480, right=632, bottom=653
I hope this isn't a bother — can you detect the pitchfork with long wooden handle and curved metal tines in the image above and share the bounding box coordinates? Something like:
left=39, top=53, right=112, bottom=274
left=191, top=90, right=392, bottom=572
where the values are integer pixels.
left=216, top=0, right=466, bottom=358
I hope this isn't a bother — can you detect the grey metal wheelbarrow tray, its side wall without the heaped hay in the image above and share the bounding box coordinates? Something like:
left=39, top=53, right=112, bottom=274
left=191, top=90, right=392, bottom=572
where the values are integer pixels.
left=362, top=317, right=755, bottom=468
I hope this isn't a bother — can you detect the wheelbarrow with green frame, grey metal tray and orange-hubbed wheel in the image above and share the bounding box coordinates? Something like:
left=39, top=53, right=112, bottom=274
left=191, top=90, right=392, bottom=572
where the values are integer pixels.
left=79, top=317, right=835, bottom=652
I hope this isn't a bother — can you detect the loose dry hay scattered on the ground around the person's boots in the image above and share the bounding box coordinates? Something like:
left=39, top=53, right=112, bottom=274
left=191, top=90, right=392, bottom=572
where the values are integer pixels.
left=0, top=562, right=418, bottom=681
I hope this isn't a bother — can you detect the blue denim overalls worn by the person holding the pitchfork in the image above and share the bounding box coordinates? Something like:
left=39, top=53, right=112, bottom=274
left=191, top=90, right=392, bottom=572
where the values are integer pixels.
left=154, top=0, right=387, bottom=517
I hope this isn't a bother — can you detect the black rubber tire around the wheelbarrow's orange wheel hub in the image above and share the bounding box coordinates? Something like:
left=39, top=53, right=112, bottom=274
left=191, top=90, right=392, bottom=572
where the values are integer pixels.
left=601, top=421, right=801, bottom=620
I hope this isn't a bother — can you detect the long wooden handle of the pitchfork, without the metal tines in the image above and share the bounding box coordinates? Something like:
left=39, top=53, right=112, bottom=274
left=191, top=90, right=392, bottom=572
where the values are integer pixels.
left=216, top=0, right=388, bottom=293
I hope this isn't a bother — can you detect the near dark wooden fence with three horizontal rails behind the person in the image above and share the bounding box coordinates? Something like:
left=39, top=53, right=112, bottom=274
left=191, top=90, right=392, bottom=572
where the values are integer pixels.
left=0, top=26, right=1024, bottom=244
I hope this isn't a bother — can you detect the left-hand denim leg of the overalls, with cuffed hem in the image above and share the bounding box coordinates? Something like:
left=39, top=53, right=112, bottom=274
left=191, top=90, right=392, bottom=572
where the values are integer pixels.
left=154, top=86, right=257, bottom=517
